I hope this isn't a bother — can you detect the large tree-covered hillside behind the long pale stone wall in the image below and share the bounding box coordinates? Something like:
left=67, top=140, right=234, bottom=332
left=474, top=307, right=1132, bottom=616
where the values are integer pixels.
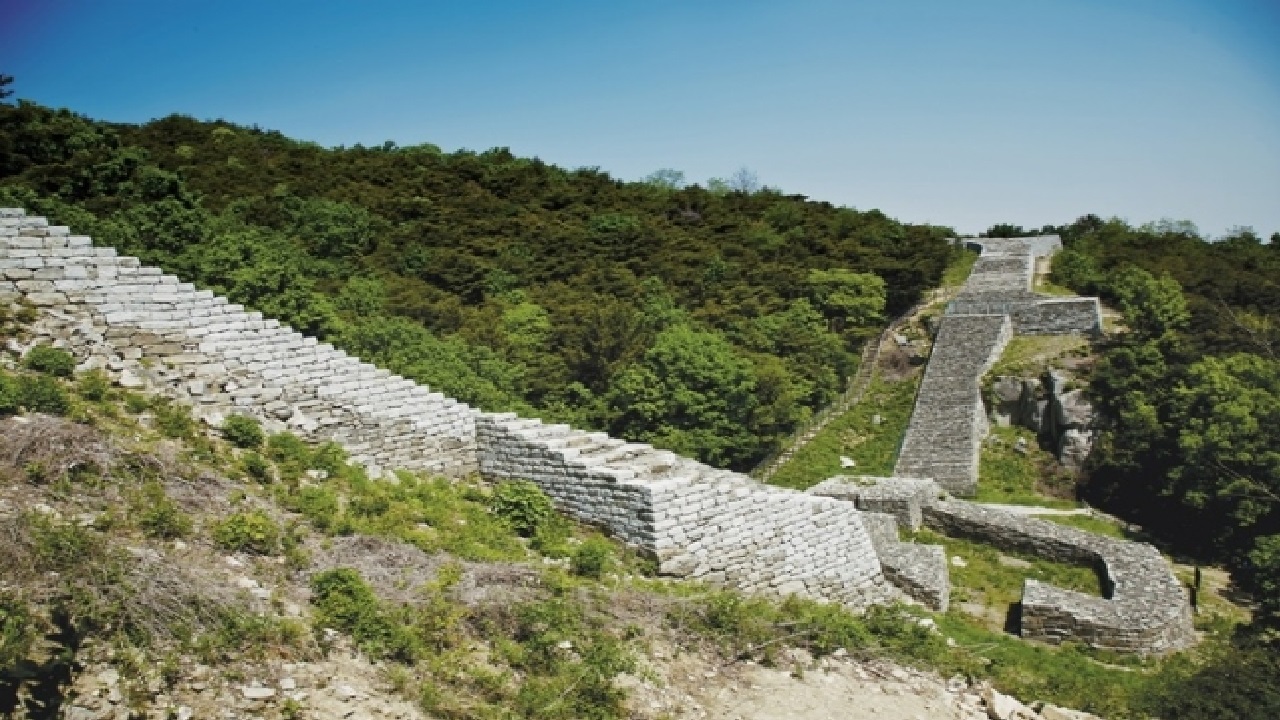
left=0, top=101, right=954, bottom=469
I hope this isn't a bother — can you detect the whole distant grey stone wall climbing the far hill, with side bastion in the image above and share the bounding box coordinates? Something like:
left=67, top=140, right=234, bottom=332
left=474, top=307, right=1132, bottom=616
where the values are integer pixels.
left=893, top=236, right=1102, bottom=496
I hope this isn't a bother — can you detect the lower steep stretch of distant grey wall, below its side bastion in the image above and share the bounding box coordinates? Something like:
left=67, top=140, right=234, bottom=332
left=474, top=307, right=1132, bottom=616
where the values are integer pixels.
left=893, top=315, right=1012, bottom=495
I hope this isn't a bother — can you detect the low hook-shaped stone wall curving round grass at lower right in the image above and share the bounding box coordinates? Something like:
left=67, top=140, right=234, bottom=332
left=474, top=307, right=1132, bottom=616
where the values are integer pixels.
left=810, top=477, right=1196, bottom=653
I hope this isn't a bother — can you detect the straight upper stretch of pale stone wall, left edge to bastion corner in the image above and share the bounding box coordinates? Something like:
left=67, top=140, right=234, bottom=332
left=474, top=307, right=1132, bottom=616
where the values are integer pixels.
left=0, top=209, right=475, bottom=474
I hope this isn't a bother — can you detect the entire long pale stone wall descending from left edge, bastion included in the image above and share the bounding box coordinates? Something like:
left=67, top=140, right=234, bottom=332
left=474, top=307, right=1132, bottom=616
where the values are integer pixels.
left=0, top=210, right=900, bottom=607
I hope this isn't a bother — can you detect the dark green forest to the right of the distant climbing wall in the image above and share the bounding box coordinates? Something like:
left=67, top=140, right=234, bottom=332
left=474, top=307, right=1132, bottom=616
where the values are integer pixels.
left=1053, top=217, right=1280, bottom=620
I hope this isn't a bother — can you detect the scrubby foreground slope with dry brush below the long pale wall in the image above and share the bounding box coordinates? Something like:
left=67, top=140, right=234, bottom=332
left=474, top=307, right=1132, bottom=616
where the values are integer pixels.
left=0, top=340, right=1266, bottom=720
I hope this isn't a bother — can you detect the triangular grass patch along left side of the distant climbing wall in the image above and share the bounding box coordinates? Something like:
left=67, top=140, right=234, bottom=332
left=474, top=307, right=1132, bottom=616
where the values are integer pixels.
left=769, top=377, right=919, bottom=489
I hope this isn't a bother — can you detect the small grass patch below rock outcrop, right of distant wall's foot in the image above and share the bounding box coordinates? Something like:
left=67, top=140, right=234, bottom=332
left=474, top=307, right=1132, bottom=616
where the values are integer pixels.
left=974, top=427, right=1078, bottom=509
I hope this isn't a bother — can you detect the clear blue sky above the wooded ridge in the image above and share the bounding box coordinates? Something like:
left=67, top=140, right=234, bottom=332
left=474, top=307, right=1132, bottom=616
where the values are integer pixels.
left=0, top=0, right=1280, bottom=236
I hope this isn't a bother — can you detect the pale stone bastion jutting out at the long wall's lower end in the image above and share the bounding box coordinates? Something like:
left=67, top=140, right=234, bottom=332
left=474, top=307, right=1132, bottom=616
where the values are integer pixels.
left=476, top=414, right=896, bottom=607
